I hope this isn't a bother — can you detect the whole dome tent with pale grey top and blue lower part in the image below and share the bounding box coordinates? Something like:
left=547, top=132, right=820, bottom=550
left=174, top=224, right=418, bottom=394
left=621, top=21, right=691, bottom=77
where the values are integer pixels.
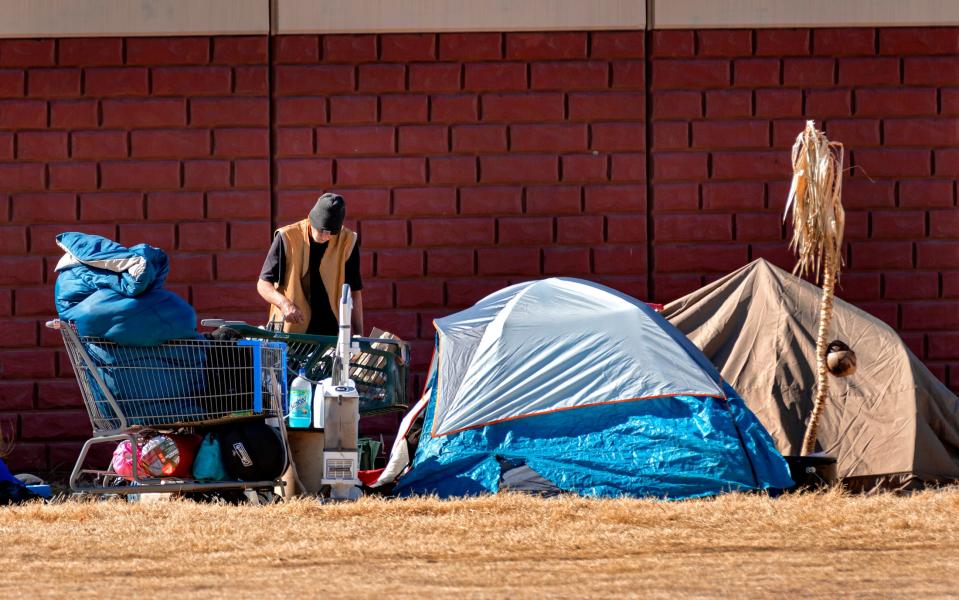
left=374, top=278, right=792, bottom=498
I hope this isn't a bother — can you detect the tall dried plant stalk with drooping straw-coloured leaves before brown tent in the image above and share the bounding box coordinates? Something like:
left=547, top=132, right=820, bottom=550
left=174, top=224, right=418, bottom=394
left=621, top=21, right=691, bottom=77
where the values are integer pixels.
left=783, top=121, right=846, bottom=456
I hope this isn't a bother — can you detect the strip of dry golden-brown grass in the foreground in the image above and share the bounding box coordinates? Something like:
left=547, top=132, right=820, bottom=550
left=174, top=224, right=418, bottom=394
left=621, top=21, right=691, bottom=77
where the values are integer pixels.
left=0, top=489, right=959, bottom=598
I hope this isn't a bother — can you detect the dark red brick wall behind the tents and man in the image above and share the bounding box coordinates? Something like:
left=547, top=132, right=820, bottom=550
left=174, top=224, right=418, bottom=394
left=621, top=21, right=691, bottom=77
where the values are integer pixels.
left=0, top=28, right=959, bottom=471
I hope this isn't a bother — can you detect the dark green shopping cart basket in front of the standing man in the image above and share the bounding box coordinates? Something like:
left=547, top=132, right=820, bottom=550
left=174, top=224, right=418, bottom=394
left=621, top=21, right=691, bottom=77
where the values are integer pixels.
left=202, top=319, right=410, bottom=416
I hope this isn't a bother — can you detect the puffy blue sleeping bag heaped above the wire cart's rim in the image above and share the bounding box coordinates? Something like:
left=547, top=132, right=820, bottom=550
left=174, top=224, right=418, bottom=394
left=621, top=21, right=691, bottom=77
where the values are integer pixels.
left=55, top=232, right=197, bottom=346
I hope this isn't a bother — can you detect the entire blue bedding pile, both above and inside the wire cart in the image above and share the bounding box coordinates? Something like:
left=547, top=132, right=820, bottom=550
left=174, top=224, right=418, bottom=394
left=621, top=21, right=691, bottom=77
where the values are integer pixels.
left=55, top=232, right=204, bottom=425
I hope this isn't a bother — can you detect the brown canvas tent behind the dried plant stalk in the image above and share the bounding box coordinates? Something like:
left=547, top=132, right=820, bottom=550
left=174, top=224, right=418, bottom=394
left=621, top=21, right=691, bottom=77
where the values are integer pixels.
left=663, top=259, right=959, bottom=489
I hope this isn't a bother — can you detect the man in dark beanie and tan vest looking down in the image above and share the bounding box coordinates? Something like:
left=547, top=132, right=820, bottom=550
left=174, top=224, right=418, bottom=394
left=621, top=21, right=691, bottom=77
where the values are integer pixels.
left=256, top=193, right=365, bottom=336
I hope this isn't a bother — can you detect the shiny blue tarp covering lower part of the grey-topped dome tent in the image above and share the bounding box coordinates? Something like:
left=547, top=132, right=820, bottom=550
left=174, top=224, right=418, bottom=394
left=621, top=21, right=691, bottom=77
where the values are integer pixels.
left=396, top=376, right=792, bottom=499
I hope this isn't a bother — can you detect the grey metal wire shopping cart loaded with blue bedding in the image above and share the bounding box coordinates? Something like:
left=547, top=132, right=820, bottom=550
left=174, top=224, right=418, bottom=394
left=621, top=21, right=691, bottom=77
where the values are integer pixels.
left=46, top=320, right=288, bottom=494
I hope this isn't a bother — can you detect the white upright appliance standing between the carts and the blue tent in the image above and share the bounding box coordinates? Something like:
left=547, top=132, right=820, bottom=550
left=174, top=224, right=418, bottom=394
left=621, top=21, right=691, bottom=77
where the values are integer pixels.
left=313, top=284, right=363, bottom=500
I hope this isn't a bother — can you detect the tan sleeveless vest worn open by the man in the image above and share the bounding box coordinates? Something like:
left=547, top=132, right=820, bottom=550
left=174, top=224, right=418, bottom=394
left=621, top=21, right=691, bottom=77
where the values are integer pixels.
left=270, top=219, right=356, bottom=333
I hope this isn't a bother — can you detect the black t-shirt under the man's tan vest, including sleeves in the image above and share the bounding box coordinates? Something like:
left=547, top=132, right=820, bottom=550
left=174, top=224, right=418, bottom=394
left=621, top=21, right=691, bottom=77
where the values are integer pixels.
left=260, top=235, right=363, bottom=335
